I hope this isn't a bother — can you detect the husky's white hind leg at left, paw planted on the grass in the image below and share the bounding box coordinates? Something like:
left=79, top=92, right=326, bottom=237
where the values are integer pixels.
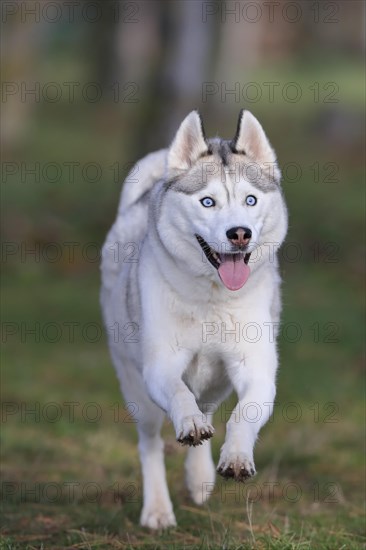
left=116, top=368, right=176, bottom=529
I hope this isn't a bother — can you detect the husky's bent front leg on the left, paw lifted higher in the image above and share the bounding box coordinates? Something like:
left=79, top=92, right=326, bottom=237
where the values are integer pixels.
left=144, top=348, right=215, bottom=446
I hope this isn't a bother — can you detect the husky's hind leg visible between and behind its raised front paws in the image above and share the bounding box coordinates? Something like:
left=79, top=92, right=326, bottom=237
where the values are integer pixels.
left=185, top=415, right=216, bottom=504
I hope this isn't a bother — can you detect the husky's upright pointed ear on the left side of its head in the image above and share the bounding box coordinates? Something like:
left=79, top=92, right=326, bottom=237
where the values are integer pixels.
left=168, top=111, right=207, bottom=171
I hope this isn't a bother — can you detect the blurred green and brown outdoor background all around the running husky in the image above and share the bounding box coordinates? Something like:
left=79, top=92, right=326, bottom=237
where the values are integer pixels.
left=1, top=0, right=365, bottom=548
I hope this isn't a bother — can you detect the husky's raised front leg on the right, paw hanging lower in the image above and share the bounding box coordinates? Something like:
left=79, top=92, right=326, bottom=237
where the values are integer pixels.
left=217, top=343, right=277, bottom=481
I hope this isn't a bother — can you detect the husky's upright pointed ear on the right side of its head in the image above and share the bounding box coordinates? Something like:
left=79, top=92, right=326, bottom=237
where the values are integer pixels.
left=233, top=109, right=276, bottom=164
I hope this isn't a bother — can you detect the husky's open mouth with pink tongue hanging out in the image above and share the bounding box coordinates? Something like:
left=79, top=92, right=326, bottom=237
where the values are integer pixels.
left=196, top=233, right=250, bottom=290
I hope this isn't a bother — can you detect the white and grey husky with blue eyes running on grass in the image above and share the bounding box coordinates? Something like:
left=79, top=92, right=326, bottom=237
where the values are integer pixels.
left=101, top=110, right=287, bottom=529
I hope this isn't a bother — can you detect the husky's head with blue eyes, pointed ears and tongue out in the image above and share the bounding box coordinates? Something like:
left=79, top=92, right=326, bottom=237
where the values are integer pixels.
left=158, top=110, right=287, bottom=290
